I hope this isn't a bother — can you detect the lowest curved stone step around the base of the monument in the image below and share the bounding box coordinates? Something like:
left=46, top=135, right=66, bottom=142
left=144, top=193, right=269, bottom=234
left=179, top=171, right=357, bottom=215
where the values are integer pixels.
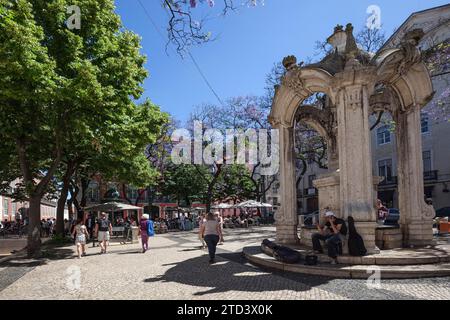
left=243, top=246, right=450, bottom=279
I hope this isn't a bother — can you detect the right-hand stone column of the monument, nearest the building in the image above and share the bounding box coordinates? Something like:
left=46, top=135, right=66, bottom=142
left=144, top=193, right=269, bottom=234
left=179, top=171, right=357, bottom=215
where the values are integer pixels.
left=396, top=106, right=434, bottom=247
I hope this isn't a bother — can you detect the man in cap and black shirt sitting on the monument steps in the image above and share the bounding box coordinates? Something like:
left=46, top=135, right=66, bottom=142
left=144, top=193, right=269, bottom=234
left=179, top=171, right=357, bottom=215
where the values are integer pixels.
left=312, top=211, right=347, bottom=264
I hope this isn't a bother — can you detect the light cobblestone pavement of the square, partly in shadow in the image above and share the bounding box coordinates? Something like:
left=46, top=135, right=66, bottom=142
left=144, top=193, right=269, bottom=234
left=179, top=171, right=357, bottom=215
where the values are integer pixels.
left=0, top=227, right=450, bottom=301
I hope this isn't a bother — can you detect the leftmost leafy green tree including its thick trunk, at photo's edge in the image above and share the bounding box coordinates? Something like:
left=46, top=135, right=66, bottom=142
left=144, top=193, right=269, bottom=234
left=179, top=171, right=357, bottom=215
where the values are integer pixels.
left=0, top=0, right=61, bottom=254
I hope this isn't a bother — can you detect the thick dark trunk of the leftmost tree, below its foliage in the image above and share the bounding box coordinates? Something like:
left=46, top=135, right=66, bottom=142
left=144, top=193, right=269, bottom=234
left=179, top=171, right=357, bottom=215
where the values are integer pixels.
left=27, top=195, right=42, bottom=258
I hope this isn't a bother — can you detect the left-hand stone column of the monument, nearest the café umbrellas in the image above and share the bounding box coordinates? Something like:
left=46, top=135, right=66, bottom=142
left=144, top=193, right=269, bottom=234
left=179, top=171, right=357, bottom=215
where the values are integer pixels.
left=275, top=125, right=300, bottom=244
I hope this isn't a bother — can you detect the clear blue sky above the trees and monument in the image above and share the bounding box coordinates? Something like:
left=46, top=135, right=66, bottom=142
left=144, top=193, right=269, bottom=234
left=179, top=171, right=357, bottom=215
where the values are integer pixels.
left=116, top=0, right=448, bottom=122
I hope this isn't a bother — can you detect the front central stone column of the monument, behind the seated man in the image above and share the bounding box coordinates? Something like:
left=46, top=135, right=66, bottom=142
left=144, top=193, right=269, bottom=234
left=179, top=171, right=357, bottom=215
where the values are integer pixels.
left=337, top=84, right=379, bottom=253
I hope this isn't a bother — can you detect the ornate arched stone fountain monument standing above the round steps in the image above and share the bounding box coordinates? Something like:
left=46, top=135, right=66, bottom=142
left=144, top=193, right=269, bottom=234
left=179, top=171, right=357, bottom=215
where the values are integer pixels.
left=269, top=24, right=434, bottom=253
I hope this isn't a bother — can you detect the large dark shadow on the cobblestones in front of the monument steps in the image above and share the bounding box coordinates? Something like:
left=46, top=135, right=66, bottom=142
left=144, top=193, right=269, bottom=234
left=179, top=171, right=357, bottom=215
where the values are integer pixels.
left=144, top=254, right=333, bottom=296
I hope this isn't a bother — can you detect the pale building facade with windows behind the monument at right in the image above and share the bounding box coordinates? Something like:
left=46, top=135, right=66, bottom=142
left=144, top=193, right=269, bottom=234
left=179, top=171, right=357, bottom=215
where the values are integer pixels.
left=371, top=5, right=450, bottom=210
